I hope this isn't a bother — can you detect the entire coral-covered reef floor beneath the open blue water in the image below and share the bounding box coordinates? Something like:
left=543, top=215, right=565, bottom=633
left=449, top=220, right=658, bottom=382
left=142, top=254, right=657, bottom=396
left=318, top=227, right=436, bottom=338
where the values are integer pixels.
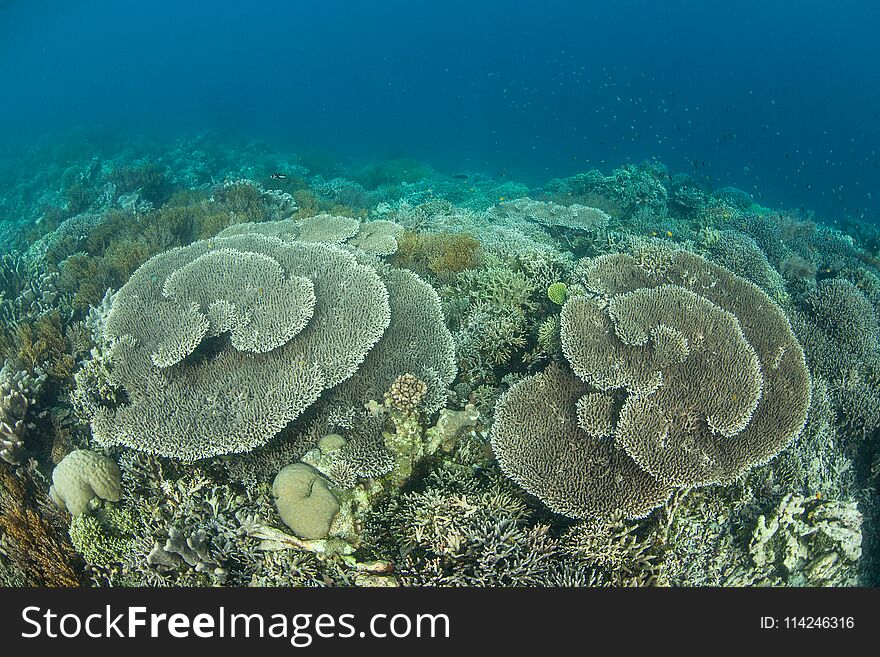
left=0, top=138, right=880, bottom=586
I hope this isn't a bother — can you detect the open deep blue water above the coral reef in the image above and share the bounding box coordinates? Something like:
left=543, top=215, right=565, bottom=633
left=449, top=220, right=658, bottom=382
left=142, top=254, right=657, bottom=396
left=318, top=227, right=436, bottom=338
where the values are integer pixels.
left=0, top=0, right=880, bottom=222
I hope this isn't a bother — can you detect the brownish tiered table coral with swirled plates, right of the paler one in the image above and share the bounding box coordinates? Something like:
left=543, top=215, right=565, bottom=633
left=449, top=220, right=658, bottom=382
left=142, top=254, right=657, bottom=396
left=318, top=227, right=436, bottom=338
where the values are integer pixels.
left=492, top=247, right=810, bottom=517
